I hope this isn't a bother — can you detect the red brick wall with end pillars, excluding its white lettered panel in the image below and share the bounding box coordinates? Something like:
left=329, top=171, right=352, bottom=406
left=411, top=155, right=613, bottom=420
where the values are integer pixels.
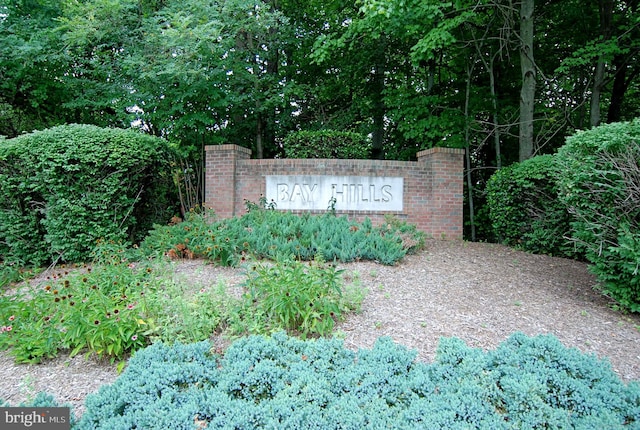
left=205, top=145, right=464, bottom=239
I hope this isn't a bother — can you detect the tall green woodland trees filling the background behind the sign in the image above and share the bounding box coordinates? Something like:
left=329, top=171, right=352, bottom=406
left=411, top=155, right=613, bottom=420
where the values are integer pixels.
left=0, top=0, right=640, bottom=239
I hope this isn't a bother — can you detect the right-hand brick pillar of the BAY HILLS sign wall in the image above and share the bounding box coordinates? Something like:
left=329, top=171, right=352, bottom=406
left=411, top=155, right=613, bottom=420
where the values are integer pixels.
left=417, top=147, right=464, bottom=240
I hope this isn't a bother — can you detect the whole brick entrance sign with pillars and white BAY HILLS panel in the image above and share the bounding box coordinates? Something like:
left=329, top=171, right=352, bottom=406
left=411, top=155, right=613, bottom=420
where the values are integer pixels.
left=205, top=145, right=464, bottom=239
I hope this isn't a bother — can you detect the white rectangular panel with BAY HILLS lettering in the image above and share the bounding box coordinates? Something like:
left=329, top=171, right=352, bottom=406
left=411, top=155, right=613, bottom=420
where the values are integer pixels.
left=266, top=175, right=404, bottom=212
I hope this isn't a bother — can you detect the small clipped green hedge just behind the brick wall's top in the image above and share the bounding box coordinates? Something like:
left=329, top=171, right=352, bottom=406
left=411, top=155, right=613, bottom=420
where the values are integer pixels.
left=284, top=130, right=371, bottom=159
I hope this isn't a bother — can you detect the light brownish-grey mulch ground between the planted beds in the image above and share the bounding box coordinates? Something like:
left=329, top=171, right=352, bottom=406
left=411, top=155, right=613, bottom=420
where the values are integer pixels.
left=0, top=241, right=640, bottom=413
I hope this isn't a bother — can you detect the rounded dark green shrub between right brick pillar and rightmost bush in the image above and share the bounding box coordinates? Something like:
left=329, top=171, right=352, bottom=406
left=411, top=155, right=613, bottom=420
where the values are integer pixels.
left=486, top=155, right=576, bottom=257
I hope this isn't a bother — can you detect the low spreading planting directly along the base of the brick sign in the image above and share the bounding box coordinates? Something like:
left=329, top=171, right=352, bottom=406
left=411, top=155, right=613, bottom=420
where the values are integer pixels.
left=140, top=208, right=424, bottom=265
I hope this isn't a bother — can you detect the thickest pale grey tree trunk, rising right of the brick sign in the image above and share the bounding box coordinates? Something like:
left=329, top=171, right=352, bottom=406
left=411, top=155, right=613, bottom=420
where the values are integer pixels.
left=519, top=0, right=536, bottom=161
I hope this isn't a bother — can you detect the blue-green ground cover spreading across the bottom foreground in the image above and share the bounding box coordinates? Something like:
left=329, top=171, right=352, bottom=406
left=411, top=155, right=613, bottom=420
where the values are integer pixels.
left=76, top=333, right=640, bottom=429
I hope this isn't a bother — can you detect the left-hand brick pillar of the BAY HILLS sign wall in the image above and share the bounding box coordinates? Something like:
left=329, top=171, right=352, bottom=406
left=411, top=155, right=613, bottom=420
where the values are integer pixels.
left=204, top=145, right=251, bottom=218
